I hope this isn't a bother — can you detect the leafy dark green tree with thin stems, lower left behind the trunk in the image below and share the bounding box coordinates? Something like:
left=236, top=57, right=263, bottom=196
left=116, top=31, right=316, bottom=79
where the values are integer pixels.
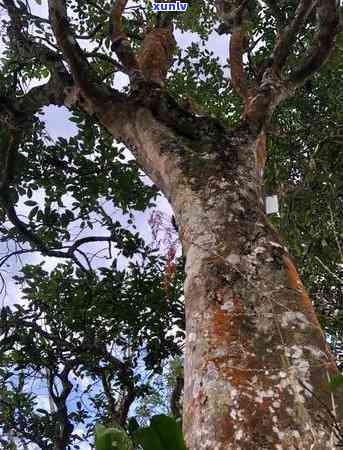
left=0, top=255, right=183, bottom=449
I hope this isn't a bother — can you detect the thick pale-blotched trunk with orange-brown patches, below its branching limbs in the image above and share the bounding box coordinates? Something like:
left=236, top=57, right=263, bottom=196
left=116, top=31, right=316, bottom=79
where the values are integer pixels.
left=98, top=102, right=343, bottom=450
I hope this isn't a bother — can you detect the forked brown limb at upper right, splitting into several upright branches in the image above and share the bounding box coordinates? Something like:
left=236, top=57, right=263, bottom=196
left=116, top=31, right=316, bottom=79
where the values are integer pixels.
left=223, top=0, right=339, bottom=131
